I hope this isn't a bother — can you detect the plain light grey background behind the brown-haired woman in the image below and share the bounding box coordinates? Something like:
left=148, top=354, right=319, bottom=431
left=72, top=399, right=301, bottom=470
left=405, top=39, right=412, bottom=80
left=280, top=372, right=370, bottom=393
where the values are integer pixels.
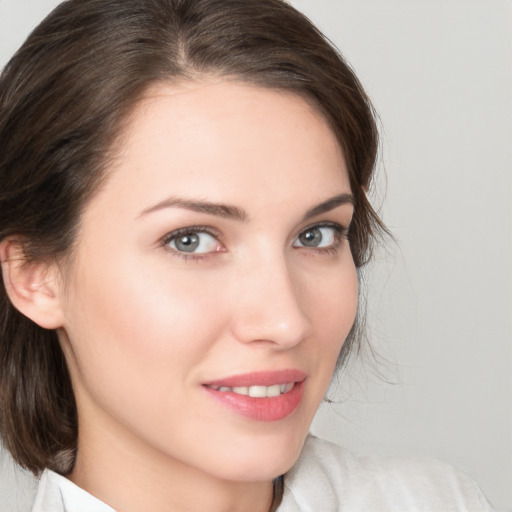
left=0, top=0, right=512, bottom=512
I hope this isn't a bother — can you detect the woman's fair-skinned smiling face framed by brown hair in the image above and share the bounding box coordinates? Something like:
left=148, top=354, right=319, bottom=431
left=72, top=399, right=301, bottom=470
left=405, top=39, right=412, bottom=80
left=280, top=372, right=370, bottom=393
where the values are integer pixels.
left=57, top=81, right=357, bottom=481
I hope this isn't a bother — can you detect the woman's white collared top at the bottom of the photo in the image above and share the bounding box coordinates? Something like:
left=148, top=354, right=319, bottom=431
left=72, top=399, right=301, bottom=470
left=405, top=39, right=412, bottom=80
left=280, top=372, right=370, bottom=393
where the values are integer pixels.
left=32, top=436, right=492, bottom=512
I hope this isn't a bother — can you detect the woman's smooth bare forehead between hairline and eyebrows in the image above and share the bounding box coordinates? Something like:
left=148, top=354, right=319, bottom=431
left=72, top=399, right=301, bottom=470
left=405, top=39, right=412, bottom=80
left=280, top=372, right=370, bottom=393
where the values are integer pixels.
left=93, top=80, right=350, bottom=214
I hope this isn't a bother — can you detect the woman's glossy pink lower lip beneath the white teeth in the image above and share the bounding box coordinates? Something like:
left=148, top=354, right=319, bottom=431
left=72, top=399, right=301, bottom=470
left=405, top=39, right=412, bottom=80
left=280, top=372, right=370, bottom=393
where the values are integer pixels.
left=204, top=382, right=304, bottom=421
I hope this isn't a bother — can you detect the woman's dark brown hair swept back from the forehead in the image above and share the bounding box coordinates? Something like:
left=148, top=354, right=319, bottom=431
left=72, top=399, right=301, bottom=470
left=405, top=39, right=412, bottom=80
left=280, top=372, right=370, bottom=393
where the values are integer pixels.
left=0, top=0, right=382, bottom=480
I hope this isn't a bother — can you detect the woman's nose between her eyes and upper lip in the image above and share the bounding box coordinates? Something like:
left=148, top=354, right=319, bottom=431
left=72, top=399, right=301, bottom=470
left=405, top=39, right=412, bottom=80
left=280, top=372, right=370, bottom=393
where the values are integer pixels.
left=232, top=258, right=313, bottom=349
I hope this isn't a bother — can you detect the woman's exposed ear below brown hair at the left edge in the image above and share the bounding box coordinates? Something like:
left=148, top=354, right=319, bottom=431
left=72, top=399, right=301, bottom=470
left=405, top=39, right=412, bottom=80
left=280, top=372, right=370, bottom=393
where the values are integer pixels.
left=0, top=238, right=64, bottom=329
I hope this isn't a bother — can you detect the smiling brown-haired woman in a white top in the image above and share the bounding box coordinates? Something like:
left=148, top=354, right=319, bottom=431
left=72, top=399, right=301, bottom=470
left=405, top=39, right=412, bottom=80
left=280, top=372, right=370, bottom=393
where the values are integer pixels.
left=0, top=0, right=494, bottom=512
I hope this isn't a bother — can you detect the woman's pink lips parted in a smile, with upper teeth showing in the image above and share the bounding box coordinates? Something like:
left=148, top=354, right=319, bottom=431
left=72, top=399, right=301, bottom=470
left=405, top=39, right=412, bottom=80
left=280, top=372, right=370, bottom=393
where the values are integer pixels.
left=203, top=370, right=306, bottom=421
